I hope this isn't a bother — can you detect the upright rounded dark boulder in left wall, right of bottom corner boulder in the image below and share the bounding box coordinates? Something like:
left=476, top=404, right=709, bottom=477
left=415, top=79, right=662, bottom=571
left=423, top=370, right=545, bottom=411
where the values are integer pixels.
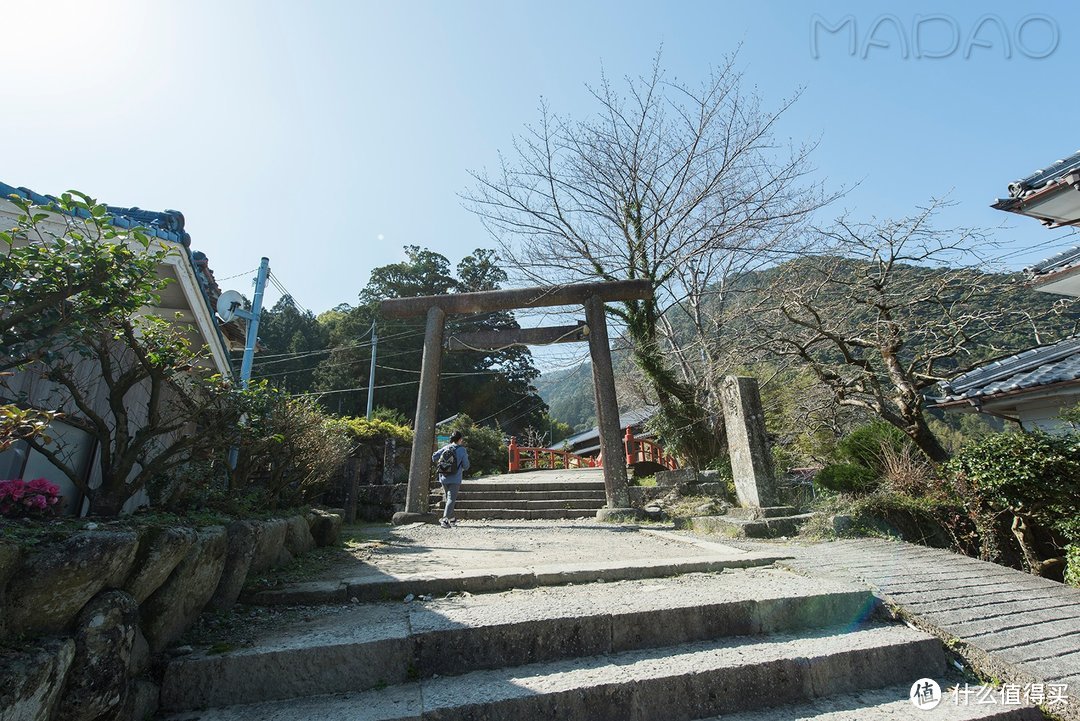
left=55, top=590, right=138, bottom=721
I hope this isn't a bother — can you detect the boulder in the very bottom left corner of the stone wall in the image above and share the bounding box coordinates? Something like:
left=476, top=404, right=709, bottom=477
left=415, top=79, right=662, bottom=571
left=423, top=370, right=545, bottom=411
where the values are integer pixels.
left=0, top=639, right=75, bottom=721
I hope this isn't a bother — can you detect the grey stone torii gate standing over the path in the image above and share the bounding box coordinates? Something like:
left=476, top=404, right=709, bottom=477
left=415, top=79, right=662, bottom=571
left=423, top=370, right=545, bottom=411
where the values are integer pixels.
left=379, top=280, right=652, bottom=525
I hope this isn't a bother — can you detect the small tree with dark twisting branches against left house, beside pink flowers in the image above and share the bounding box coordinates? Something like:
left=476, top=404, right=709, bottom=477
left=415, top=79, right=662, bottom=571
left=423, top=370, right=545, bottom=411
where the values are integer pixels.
left=26, top=315, right=239, bottom=516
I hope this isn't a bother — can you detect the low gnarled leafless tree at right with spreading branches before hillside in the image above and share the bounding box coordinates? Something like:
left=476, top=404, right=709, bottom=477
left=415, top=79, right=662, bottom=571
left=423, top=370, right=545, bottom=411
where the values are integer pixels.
left=744, top=201, right=1075, bottom=462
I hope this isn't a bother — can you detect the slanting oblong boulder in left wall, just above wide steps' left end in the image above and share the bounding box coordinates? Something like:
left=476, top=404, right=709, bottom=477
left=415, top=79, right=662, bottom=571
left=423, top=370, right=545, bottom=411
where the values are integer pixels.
left=140, top=526, right=228, bottom=653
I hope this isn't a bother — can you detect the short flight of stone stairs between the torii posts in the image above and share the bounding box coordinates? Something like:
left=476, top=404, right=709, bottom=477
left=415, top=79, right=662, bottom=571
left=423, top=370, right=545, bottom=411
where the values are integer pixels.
left=430, top=479, right=606, bottom=520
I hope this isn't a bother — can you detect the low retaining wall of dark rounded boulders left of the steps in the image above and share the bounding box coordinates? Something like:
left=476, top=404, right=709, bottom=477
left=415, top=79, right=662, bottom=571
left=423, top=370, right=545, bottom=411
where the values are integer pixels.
left=0, top=511, right=341, bottom=721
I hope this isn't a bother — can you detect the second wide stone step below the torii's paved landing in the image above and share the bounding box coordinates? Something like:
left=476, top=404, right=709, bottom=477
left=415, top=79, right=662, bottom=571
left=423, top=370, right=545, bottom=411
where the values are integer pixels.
left=159, top=625, right=945, bottom=721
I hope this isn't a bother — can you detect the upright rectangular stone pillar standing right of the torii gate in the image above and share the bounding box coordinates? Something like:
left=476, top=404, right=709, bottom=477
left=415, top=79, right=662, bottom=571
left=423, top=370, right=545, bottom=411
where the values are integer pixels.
left=720, top=376, right=780, bottom=508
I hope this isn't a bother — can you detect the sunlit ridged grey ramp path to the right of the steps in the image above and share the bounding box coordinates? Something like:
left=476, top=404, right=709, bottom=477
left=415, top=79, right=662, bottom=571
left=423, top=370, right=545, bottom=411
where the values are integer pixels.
left=733, top=539, right=1080, bottom=720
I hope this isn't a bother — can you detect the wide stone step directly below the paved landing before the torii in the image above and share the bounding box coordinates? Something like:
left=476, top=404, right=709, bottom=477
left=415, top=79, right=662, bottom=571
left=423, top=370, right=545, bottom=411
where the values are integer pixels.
left=162, top=569, right=875, bottom=709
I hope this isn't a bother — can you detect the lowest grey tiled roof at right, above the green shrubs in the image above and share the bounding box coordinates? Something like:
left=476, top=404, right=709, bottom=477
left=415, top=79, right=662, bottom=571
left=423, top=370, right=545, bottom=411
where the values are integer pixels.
left=937, top=336, right=1080, bottom=404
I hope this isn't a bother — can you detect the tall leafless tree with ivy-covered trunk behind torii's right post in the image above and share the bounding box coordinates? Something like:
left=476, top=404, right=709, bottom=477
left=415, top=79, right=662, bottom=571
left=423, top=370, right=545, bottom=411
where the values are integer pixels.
left=465, top=55, right=826, bottom=462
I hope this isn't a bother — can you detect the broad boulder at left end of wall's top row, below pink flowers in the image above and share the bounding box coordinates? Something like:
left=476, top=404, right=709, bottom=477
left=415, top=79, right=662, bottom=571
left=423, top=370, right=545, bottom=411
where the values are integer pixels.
left=4, top=531, right=138, bottom=636
